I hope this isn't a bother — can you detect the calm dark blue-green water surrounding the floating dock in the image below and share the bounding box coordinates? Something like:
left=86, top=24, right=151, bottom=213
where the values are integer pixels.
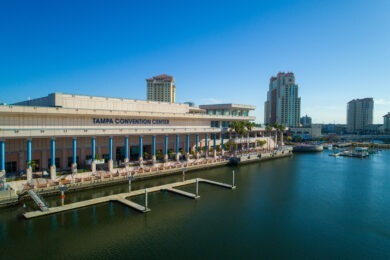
left=0, top=151, right=390, bottom=259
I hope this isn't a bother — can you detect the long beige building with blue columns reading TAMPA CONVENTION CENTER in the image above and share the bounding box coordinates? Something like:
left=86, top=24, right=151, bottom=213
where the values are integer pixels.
left=0, top=93, right=260, bottom=180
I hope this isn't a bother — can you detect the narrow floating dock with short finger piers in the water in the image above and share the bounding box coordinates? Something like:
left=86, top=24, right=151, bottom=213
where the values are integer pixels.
left=23, top=178, right=236, bottom=219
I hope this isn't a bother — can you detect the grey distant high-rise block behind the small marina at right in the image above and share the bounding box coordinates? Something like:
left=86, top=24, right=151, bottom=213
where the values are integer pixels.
left=347, top=98, right=374, bottom=133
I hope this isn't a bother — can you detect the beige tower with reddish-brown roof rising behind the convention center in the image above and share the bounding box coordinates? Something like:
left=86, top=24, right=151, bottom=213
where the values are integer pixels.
left=146, top=74, right=176, bottom=103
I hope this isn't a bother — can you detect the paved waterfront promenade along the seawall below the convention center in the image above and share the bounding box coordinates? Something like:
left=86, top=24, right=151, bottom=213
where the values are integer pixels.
left=0, top=147, right=291, bottom=206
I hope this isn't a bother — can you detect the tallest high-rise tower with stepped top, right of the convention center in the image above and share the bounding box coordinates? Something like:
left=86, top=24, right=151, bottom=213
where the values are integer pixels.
left=264, top=72, right=301, bottom=127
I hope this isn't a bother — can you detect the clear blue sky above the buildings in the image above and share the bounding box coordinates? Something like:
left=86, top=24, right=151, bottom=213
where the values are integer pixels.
left=0, top=0, right=390, bottom=123
